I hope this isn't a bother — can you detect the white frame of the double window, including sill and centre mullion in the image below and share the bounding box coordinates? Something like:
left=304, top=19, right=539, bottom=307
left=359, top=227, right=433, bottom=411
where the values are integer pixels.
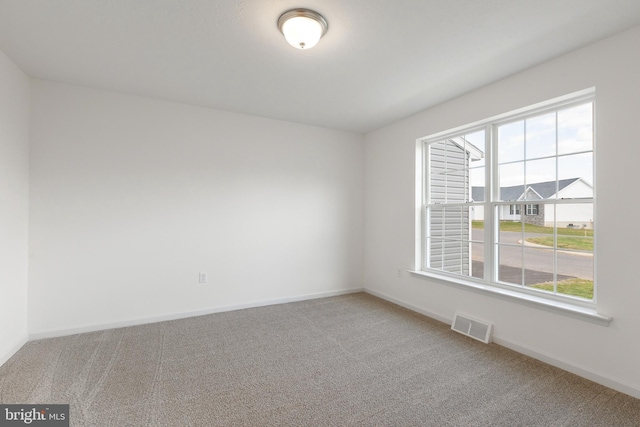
left=411, top=88, right=611, bottom=325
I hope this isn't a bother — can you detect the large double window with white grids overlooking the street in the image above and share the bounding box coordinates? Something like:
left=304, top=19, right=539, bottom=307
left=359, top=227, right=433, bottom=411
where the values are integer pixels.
left=418, top=92, right=595, bottom=306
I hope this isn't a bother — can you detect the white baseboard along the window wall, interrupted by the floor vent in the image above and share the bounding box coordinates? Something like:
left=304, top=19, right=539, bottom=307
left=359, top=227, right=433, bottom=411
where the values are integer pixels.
left=364, top=289, right=640, bottom=399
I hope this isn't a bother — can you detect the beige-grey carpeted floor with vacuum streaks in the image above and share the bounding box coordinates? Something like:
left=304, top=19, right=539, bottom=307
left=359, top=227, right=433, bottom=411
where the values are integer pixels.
left=0, top=294, right=640, bottom=427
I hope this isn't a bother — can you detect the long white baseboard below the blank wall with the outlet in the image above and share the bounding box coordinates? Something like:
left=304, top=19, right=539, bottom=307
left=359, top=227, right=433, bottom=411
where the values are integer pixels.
left=29, top=288, right=364, bottom=341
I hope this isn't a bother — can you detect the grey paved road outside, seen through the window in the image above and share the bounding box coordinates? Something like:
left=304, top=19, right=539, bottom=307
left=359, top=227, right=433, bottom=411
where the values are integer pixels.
left=472, top=229, right=593, bottom=284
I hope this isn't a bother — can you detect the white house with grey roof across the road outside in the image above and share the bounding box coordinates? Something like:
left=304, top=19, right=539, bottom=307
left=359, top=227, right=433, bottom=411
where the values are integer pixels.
left=471, top=178, right=593, bottom=228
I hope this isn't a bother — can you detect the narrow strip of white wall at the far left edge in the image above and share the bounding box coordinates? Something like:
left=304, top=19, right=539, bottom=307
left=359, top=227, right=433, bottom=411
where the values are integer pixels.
left=0, top=51, right=29, bottom=365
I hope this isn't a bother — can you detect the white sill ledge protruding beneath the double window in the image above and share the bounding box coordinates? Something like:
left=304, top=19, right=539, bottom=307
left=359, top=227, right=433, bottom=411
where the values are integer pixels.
left=409, top=270, right=612, bottom=326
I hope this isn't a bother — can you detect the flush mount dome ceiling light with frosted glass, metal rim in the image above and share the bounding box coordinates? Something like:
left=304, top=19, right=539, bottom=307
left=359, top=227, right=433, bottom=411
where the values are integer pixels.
left=278, top=9, right=329, bottom=49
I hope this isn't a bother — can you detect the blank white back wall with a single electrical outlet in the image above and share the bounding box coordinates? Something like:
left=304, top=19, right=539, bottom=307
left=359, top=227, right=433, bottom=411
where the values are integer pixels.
left=29, top=80, right=364, bottom=337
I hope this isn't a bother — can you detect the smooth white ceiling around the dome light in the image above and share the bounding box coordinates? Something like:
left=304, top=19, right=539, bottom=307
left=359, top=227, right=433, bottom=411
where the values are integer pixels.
left=0, top=0, right=640, bottom=133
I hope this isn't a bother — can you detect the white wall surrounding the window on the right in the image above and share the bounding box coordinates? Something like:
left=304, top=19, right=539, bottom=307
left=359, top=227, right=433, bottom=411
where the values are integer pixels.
left=365, top=28, right=640, bottom=397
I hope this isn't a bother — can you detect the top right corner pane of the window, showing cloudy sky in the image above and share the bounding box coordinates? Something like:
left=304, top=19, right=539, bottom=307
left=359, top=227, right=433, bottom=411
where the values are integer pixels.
left=558, top=103, right=593, bottom=154
